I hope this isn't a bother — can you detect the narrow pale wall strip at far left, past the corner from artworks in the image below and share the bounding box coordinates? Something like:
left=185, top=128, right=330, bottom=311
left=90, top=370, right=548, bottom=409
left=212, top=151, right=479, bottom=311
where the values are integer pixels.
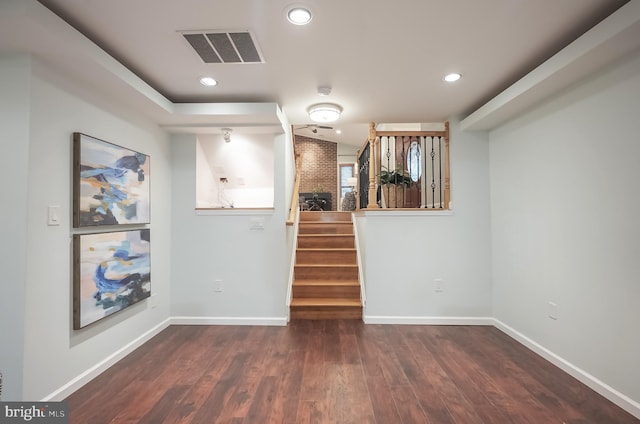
left=0, top=55, right=31, bottom=401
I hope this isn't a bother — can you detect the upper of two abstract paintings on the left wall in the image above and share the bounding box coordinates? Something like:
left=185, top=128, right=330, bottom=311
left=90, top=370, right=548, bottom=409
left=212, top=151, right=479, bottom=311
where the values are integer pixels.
left=73, top=133, right=150, bottom=228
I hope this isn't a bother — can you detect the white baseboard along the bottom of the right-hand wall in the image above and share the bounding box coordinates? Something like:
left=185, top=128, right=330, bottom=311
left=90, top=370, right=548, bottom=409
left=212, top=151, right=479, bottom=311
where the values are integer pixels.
left=493, top=318, right=640, bottom=419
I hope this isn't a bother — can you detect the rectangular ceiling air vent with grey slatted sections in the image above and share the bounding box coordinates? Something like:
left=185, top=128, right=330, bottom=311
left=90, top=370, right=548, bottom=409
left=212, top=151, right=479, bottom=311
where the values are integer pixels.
left=182, top=31, right=264, bottom=63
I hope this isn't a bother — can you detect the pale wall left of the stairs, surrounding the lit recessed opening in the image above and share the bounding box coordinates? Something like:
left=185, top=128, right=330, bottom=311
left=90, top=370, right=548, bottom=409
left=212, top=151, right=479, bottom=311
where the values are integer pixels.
left=171, top=135, right=290, bottom=323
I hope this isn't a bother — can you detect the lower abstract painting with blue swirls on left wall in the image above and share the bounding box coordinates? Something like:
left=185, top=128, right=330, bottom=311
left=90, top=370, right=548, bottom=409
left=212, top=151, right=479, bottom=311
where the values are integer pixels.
left=73, top=229, right=151, bottom=330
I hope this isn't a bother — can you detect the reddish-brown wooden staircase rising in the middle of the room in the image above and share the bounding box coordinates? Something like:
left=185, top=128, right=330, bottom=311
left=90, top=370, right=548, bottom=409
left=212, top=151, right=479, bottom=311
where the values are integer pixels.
left=291, top=211, right=362, bottom=319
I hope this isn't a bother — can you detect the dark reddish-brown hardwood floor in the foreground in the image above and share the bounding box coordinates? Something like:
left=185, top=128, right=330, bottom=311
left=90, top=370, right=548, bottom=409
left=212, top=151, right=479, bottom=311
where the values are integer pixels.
left=67, top=320, right=640, bottom=424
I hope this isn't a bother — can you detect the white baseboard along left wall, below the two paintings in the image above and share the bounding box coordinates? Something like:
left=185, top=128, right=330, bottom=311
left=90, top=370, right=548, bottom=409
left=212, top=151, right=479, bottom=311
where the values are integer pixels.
left=42, top=318, right=170, bottom=402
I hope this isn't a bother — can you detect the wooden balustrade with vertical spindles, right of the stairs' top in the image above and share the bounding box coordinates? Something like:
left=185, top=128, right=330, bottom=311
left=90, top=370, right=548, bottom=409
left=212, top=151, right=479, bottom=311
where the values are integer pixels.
left=356, top=122, right=451, bottom=210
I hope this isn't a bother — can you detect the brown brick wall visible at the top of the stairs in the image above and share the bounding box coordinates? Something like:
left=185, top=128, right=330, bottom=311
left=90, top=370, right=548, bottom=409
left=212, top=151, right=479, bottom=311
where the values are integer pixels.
left=295, top=135, right=340, bottom=211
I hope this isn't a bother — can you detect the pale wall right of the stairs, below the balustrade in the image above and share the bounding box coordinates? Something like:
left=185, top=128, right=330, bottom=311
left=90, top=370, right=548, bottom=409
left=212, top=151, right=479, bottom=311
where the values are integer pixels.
left=357, top=117, right=491, bottom=322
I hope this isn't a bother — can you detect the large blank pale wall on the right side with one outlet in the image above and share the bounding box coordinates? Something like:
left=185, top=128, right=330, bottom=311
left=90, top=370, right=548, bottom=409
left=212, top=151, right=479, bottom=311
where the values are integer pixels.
left=490, top=52, right=640, bottom=402
